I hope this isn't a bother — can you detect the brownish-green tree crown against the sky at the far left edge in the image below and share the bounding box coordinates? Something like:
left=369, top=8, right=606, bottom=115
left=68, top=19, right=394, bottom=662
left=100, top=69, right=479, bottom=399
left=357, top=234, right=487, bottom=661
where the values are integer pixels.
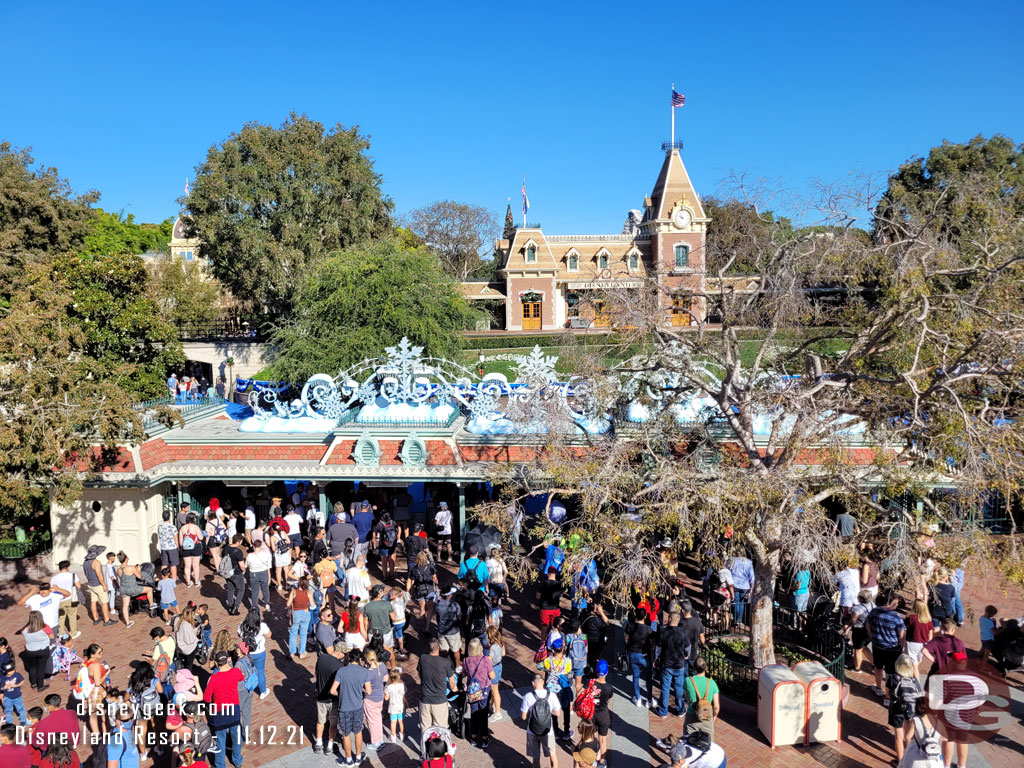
left=0, top=141, right=99, bottom=308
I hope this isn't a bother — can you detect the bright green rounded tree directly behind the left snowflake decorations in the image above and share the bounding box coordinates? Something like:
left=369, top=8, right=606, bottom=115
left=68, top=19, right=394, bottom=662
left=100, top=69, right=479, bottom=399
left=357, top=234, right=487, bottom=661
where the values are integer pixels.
left=270, top=238, right=469, bottom=382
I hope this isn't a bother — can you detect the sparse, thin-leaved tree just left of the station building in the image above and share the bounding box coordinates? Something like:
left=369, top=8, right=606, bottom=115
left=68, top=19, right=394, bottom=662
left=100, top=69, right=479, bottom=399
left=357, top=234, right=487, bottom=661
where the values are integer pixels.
left=409, top=200, right=498, bottom=281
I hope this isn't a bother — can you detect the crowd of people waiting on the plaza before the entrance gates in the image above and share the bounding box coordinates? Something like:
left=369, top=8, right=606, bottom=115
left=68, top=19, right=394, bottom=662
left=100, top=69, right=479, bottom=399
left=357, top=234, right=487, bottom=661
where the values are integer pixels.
left=0, top=493, right=1021, bottom=768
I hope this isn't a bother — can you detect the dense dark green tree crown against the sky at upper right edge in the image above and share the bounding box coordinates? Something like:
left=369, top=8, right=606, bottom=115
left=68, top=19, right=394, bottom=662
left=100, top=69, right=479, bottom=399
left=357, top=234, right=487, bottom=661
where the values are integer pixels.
left=872, top=134, right=1024, bottom=249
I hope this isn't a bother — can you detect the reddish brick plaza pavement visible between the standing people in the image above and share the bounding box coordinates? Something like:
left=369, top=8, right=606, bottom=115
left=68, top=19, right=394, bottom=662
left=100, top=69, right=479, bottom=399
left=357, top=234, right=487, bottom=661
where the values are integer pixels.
left=0, top=552, right=1024, bottom=768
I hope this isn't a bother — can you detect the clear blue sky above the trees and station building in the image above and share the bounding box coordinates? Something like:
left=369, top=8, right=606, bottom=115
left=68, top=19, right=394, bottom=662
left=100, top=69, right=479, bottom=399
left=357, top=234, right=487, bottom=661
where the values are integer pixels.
left=0, top=1, right=1024, bottom=232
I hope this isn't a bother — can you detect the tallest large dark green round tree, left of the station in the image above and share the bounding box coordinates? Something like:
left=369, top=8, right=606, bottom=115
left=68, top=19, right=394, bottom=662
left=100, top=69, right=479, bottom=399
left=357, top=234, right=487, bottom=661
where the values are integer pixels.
left=181, top=113, right=392, bottom=317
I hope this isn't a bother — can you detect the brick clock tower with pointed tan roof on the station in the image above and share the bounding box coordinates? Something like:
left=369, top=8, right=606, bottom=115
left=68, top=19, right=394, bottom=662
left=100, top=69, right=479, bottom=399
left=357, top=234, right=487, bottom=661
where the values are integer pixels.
left=641, top=141, right=709, bottom=326
